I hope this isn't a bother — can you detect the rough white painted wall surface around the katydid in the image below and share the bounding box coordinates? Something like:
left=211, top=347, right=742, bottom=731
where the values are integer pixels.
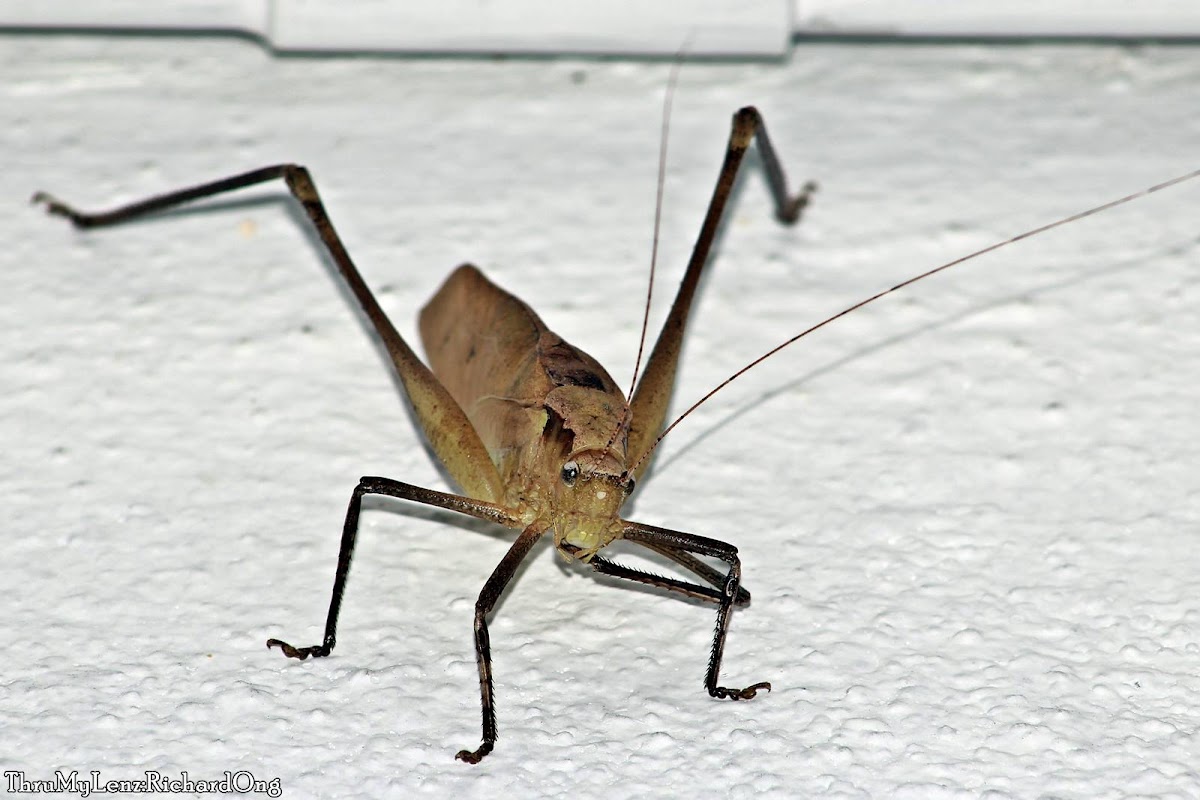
left=7, top=37, right=1200, bottom=798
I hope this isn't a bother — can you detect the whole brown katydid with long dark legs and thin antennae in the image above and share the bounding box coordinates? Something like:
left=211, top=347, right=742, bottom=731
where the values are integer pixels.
left=35, top=108, right=1200, bottom=763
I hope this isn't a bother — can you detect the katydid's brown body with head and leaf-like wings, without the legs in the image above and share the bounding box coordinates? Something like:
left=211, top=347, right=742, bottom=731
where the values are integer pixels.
left=420, top=265, right=640, bottom=561
